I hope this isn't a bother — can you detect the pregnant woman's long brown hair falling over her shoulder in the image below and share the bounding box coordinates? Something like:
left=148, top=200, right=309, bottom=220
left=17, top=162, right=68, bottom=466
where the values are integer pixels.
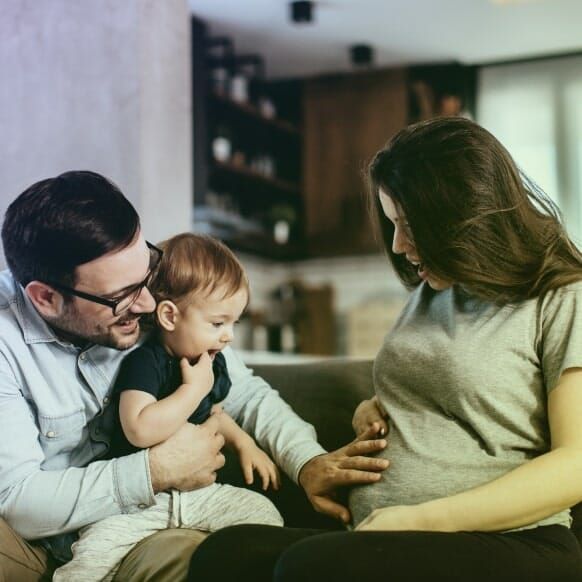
left=368, top=117, right=582, bottom=304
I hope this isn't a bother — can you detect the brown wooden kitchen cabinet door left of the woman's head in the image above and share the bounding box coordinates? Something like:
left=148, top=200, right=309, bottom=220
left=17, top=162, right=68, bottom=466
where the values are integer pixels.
left=303, top=69, right=408, bottom=256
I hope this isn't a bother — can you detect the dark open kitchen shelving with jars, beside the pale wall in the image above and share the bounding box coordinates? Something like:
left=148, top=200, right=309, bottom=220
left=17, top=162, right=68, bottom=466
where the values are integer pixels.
left=192, top=19, right=305, bottom=260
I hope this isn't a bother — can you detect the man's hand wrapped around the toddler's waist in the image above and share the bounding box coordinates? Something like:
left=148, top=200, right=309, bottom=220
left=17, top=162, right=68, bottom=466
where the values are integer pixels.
left=149, top=416, right=224, bottom=493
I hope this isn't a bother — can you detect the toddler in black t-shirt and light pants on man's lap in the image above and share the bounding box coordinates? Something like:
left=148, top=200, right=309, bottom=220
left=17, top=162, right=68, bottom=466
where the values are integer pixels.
left=53, top=233, right=283, bottom=582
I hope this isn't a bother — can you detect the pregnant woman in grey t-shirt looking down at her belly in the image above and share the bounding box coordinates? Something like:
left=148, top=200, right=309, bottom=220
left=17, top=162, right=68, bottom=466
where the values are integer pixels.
left=187, top=118, right=582, bottom=582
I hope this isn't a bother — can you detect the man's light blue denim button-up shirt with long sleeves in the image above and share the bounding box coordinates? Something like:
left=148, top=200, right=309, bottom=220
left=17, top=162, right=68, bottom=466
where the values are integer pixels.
left=0, top=271, right=325, bottom=539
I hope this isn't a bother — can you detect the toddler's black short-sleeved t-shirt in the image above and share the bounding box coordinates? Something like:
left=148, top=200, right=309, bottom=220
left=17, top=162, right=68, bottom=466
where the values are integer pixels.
left=107, top=338, right=231, bottom=458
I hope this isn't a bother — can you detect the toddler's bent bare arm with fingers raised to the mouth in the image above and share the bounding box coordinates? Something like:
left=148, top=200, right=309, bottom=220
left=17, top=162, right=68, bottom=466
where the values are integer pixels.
left=119, top=353, right=214, bottom=448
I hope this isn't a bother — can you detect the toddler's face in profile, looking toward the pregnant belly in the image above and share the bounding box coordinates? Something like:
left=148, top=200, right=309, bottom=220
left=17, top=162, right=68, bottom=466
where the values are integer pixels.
left=173, top=287, right=248, bottom=362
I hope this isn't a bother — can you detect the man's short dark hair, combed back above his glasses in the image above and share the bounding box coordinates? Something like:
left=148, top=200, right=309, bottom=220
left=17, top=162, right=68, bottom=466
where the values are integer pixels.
left=2, top=171, right=139, bottom=286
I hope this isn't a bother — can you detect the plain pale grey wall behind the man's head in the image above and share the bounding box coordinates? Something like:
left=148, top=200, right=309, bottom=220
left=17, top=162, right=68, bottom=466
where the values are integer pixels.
left=0, top=0, right=192, bottom=265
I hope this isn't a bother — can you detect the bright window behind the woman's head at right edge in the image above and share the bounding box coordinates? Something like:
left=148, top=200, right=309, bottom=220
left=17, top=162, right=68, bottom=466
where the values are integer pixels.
left=477, top=56, right=582, bottom=244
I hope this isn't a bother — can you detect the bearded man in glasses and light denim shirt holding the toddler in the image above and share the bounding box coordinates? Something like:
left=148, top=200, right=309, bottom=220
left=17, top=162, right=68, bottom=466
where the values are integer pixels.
left=0, top=171, right=392, bottom=580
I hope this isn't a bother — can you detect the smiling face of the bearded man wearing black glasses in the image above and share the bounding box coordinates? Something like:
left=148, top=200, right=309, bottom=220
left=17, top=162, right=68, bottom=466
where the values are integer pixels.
left=48, top=233, right=155, bottom=350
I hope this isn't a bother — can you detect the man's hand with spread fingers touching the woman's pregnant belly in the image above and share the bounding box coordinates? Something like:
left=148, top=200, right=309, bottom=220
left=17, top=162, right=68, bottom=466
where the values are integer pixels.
left=299, top=427, right=389, bottom=523
